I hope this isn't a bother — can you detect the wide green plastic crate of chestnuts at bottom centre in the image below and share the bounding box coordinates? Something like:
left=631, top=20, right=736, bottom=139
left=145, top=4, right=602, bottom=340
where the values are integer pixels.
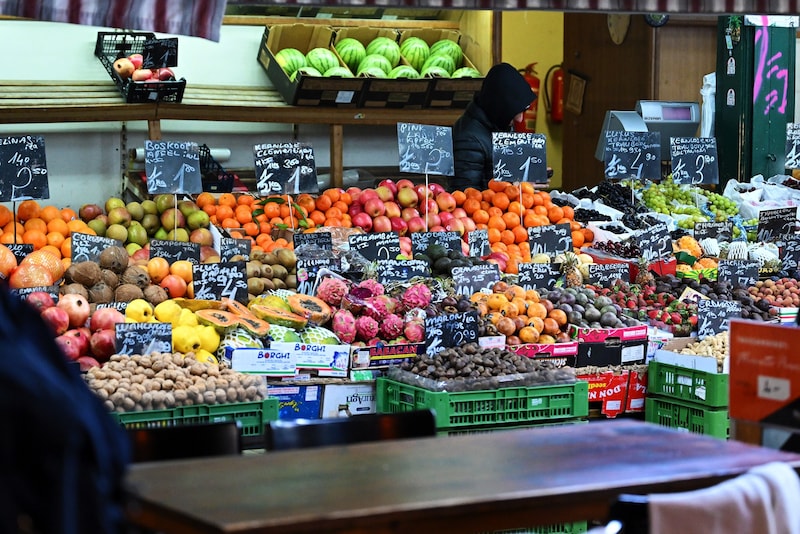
left=376, top=377, right=589, bottom=430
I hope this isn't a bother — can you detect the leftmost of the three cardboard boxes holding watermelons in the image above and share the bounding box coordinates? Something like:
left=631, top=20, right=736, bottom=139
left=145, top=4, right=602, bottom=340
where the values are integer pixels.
left=258, top=24, right=366, bottom=108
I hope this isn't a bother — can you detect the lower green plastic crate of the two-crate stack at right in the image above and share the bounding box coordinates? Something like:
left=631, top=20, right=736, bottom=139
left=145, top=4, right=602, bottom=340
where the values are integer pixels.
left=644, top=397, right=730, bottom=439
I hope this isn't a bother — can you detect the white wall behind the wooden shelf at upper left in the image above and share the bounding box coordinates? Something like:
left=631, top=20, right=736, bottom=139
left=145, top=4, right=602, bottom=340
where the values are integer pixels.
left=0, top=20, right=400, bottom=209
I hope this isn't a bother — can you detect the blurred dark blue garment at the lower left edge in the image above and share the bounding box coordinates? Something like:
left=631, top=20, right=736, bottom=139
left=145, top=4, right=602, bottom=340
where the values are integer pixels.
left=0, top=287, right=130, bottom=534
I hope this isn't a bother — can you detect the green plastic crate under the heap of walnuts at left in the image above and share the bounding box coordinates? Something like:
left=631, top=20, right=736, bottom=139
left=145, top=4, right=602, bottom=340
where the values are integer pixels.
left=111, top=397, right=278, bottom=437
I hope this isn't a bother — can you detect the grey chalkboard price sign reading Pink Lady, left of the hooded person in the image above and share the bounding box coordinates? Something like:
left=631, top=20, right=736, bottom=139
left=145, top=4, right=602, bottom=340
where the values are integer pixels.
left=397, top=122, right=454, bottom=176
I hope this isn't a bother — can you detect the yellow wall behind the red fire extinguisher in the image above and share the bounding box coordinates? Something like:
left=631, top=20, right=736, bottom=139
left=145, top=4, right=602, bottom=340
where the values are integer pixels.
left=500, top=11, right=564, bottom=188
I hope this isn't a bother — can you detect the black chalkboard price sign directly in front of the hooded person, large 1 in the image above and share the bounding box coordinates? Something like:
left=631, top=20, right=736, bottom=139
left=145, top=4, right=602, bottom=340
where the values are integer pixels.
left=492, top=132, right=547, bottom=184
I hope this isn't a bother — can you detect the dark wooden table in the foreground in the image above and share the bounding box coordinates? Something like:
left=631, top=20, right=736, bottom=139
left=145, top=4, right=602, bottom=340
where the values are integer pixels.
left=127, top=421, right=800, bottom=534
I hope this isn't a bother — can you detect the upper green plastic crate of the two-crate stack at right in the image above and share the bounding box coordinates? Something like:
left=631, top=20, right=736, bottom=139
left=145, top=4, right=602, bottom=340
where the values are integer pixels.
left=647, top=360, right=729, bottom=408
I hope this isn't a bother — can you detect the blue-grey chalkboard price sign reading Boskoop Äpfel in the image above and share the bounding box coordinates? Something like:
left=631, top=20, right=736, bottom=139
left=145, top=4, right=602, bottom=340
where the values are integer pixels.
left=144, top=140, right=203, bottom=195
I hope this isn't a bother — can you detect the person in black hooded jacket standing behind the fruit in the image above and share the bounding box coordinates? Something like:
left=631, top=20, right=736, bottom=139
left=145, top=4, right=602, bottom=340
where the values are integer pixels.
left=449, top=63, right=536, bottom=190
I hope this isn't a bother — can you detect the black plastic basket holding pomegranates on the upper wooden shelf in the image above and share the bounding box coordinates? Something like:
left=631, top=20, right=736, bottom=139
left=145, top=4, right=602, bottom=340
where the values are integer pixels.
left=94, top=32, right=186, bottom=103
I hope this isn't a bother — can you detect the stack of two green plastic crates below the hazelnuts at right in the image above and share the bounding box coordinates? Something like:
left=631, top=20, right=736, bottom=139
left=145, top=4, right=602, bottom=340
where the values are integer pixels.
left=645, top=361, right=730, bottom=439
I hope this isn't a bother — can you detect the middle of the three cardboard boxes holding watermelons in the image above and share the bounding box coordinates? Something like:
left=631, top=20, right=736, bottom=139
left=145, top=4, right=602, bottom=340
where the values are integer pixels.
left=334, top=28, right=432, bottom=109
